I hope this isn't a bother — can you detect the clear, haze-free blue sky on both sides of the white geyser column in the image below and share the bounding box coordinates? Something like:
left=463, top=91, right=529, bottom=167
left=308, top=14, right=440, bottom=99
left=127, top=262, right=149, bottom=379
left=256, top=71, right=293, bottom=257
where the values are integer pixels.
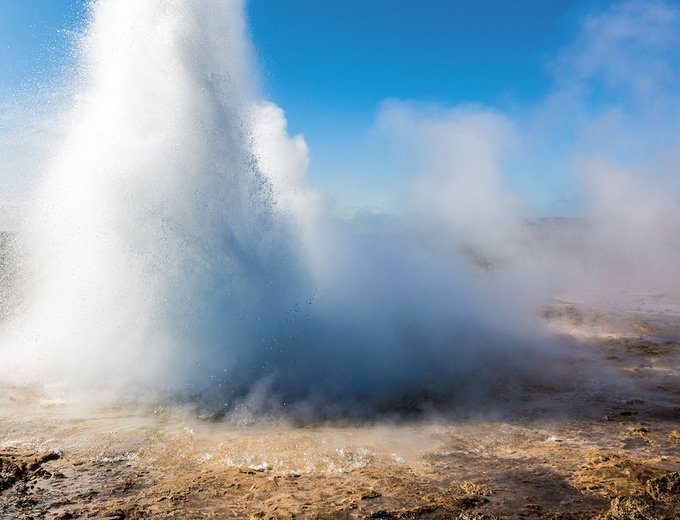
left=5, top=0, right=676, bottom=215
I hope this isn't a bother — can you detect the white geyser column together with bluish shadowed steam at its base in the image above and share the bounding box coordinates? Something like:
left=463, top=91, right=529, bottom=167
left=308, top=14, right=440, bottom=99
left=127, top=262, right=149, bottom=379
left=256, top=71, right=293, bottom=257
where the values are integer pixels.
left=2, top=0, right=568, bottom=413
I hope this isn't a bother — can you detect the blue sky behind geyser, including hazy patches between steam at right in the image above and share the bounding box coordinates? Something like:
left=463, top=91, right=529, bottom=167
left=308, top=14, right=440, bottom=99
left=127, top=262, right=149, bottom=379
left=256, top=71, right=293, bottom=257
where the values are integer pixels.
left=0, top=0, right=680, bottom=212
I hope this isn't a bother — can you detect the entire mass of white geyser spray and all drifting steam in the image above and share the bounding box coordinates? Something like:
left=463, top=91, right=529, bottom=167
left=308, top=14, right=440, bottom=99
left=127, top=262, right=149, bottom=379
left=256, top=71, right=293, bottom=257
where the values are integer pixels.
left=0, top=0, right=680, bottom=413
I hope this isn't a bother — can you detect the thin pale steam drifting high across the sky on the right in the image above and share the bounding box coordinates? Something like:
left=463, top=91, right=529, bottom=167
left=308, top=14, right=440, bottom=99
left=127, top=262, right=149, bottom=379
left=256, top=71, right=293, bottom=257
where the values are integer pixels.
left=377, top=1, right=680, bottom=310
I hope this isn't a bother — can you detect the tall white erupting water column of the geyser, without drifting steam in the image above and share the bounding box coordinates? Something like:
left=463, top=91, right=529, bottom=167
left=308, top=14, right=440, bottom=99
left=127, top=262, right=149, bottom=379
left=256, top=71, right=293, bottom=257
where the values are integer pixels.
left=0, top=0, right=308, bottom=393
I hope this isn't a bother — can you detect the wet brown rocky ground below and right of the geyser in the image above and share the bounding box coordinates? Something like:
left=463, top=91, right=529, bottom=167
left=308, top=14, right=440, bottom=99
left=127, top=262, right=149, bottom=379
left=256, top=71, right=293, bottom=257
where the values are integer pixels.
left=0, top=303, right=680, bottom=519
